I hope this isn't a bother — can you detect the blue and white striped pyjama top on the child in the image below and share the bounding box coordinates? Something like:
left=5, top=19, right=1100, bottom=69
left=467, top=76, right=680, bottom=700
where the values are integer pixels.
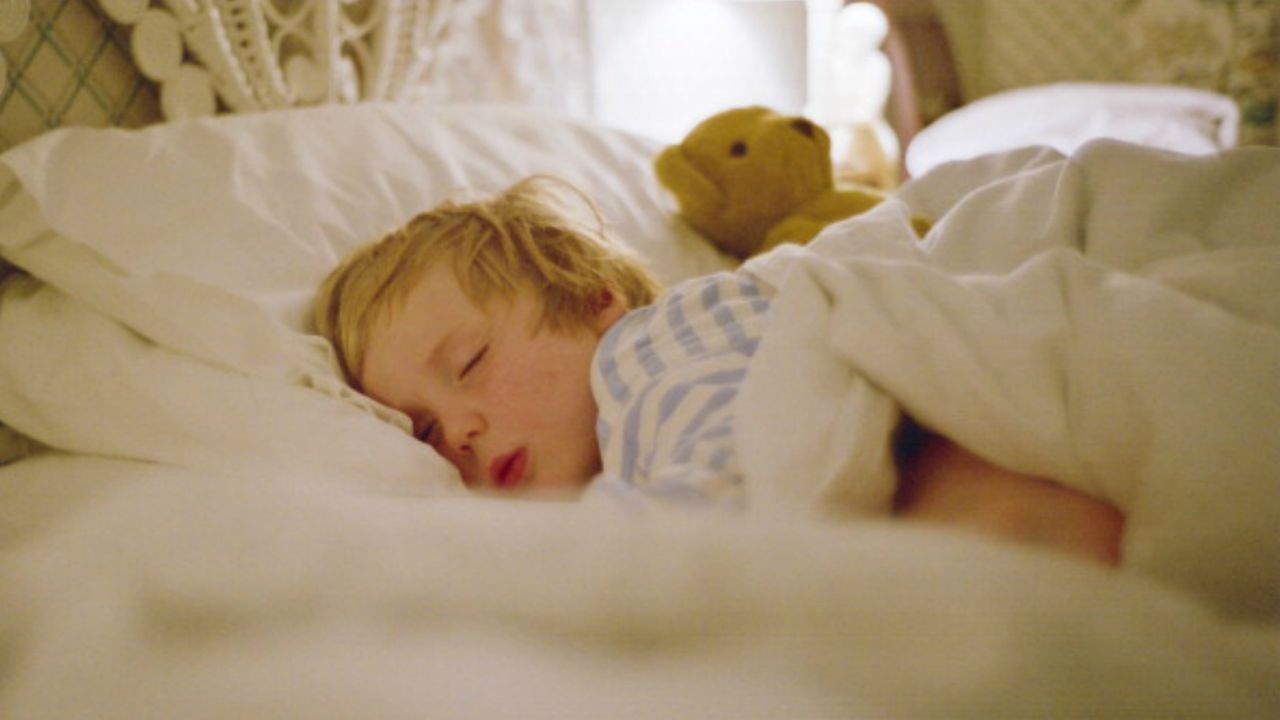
left=591, top=270, right=772, bottom=509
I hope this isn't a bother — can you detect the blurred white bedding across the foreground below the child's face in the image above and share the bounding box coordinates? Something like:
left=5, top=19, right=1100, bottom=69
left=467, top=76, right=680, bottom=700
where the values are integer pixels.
left=0, top=456, right=1280, bottom=720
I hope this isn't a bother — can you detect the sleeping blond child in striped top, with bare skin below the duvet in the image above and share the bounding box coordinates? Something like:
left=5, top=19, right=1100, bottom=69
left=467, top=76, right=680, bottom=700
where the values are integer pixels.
left=315, top=178, right=1124, bottom=565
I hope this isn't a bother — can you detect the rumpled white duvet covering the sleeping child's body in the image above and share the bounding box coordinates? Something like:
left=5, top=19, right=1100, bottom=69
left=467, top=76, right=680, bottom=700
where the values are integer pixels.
left=737, top=141, right=1280, bottom=620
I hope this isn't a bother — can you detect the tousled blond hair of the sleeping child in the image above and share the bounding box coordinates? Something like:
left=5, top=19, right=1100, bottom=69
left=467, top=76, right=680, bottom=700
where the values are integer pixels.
left=314, top=176, right=658, bottom=388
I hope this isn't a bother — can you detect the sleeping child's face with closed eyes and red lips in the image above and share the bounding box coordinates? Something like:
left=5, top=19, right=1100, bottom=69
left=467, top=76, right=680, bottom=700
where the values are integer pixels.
left=360, top=265, right=625, bottom=492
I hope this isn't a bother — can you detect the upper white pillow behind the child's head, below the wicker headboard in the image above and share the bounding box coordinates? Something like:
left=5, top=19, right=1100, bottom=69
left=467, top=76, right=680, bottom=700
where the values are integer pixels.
left=0, top=104, right=728, bottom=322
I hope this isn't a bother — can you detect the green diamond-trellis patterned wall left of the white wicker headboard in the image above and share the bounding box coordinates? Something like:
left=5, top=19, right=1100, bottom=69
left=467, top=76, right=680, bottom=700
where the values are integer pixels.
left=0, top=0, right=160, bottom=150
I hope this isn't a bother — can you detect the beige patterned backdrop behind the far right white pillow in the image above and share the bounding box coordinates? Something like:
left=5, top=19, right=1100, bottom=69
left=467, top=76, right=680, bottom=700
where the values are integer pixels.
left=934, top=0, right=1280, bottom=145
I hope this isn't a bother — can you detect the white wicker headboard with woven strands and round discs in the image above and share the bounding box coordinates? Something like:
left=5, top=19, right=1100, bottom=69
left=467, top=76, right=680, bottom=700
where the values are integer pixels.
left=119, top=0, right=452, bottom=119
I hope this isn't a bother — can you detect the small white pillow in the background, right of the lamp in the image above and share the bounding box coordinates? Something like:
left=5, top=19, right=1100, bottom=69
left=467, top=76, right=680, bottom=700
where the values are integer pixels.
left=905, top=82, right=1240, bottom=177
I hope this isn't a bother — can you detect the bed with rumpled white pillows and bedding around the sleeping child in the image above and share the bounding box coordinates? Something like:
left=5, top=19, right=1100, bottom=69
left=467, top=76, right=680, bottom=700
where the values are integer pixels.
left=0, top=1, right=1280, bottom=719
